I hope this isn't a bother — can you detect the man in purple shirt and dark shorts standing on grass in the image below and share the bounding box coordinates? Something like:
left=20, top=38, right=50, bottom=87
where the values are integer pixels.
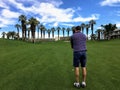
left=71, top=26, right=87, bottom=88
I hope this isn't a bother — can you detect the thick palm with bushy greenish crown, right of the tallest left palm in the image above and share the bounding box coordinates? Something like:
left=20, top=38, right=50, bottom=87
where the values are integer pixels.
left=28, top=17, right=39, bottom=43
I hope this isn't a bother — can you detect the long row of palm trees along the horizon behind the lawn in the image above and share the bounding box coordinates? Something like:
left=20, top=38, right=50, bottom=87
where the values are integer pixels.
left=2, top=15, right=117, bottom=43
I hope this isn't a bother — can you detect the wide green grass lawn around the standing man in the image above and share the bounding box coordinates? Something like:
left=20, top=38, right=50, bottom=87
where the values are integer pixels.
left=0, top=39, right=120, bottom=90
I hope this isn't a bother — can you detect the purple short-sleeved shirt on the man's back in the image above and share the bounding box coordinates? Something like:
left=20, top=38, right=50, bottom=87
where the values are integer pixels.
left=71, top=32, right=87, bottom=51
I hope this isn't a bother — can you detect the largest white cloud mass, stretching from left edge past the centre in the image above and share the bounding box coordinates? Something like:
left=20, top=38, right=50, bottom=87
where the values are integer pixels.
left=0, top=0, right=99, bottom=27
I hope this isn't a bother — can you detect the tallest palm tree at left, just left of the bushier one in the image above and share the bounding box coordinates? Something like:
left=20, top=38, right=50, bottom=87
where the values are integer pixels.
left=19, top=15, right=27, bottom=40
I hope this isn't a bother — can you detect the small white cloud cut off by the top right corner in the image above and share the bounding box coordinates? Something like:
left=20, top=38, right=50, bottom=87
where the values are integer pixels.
left=100, top=0, right=120, bottom=6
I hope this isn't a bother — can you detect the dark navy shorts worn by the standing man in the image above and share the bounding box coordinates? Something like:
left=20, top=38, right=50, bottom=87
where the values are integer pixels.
left=73, top=51, right=87, bottom=67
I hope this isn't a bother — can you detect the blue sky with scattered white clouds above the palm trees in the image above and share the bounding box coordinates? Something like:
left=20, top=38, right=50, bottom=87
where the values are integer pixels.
left=0, top=0, right=120, bottom=35
